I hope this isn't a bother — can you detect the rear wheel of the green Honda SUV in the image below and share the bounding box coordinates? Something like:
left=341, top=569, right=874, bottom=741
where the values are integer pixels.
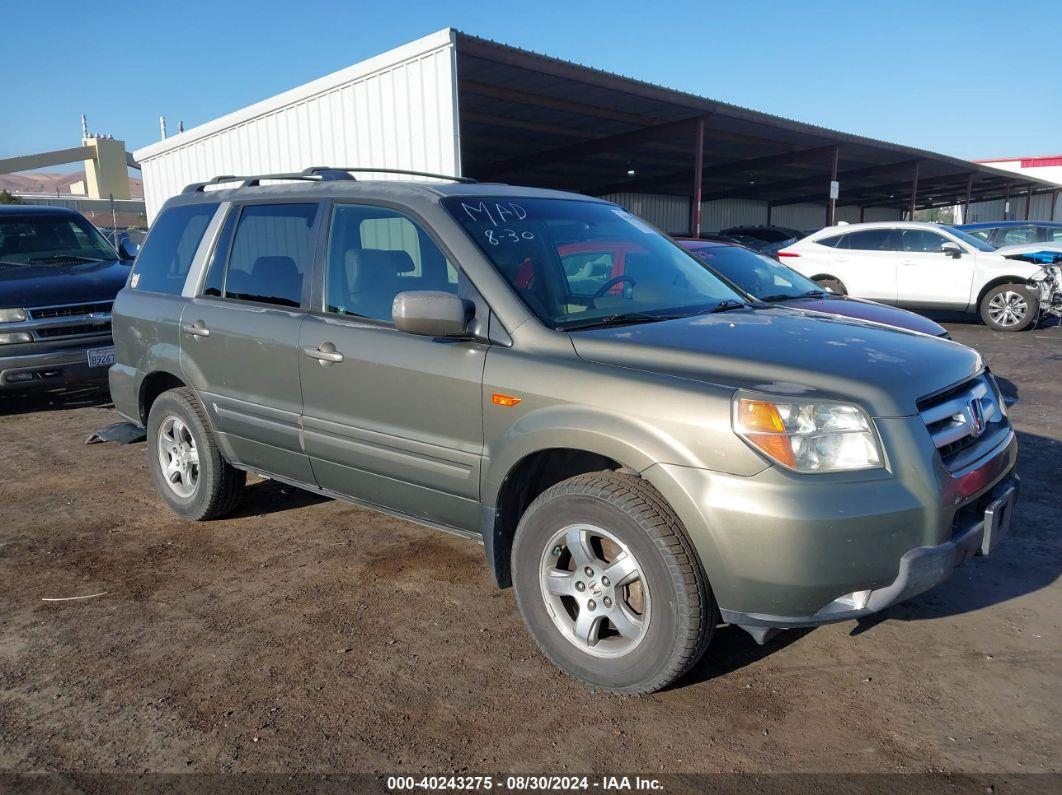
left=148, top=388, right=246, bottom=521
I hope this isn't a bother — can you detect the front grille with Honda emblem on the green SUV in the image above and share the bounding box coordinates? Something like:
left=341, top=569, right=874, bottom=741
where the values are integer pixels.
left=918, top=373, right=1009, bottom=469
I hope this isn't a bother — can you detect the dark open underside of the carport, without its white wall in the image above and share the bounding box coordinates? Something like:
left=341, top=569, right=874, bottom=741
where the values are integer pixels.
left=455, top=32, right=1059, bottom=234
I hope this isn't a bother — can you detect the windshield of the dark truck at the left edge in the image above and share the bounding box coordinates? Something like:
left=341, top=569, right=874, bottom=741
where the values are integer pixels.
left=0, top=213, right=118, bottom=265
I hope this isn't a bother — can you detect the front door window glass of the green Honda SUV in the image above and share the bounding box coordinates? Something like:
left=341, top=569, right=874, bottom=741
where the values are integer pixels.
left=325, top=205, right=458, bottom=323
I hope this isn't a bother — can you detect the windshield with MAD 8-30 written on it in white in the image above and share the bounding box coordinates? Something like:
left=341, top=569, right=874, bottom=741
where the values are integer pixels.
left=444, top=196, right=743, bottom=329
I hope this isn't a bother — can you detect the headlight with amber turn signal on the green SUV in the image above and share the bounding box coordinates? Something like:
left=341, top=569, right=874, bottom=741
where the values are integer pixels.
left=733, top=393, right=881, bottom=472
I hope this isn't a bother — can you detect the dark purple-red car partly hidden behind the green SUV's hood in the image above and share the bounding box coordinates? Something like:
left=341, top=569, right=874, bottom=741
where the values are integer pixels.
left=678, top=239, right=949, bottom=339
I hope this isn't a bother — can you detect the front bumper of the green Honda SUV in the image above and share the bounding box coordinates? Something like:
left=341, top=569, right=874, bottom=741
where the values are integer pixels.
left=643, top=417, right=1017, bottom=627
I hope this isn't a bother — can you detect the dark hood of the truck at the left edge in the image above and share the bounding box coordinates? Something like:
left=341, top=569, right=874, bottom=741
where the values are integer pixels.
left=0, top=260, right=130, bottom=309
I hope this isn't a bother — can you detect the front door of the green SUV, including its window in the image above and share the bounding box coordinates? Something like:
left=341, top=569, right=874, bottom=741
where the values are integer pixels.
left=298, top=205, right=486, bottom=530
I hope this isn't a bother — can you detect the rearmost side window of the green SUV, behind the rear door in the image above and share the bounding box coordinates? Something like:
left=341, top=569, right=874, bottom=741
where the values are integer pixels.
left=130, top=204, right=218, bottom=295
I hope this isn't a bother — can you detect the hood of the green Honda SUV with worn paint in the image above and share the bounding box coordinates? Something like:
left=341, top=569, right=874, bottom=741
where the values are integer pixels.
left=570, top=308, right=983, bottom=417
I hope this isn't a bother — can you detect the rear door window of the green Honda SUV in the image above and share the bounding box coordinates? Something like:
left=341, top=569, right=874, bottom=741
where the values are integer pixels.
left=224, top=204, right=318, bottom=307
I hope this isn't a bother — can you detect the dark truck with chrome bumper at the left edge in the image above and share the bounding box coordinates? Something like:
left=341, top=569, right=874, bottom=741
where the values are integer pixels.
left=0, top=205, right=135, bottom=392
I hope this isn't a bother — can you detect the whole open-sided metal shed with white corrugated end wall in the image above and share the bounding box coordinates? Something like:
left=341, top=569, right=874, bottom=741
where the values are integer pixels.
left=135, top=29, right=1059, bottom=234
